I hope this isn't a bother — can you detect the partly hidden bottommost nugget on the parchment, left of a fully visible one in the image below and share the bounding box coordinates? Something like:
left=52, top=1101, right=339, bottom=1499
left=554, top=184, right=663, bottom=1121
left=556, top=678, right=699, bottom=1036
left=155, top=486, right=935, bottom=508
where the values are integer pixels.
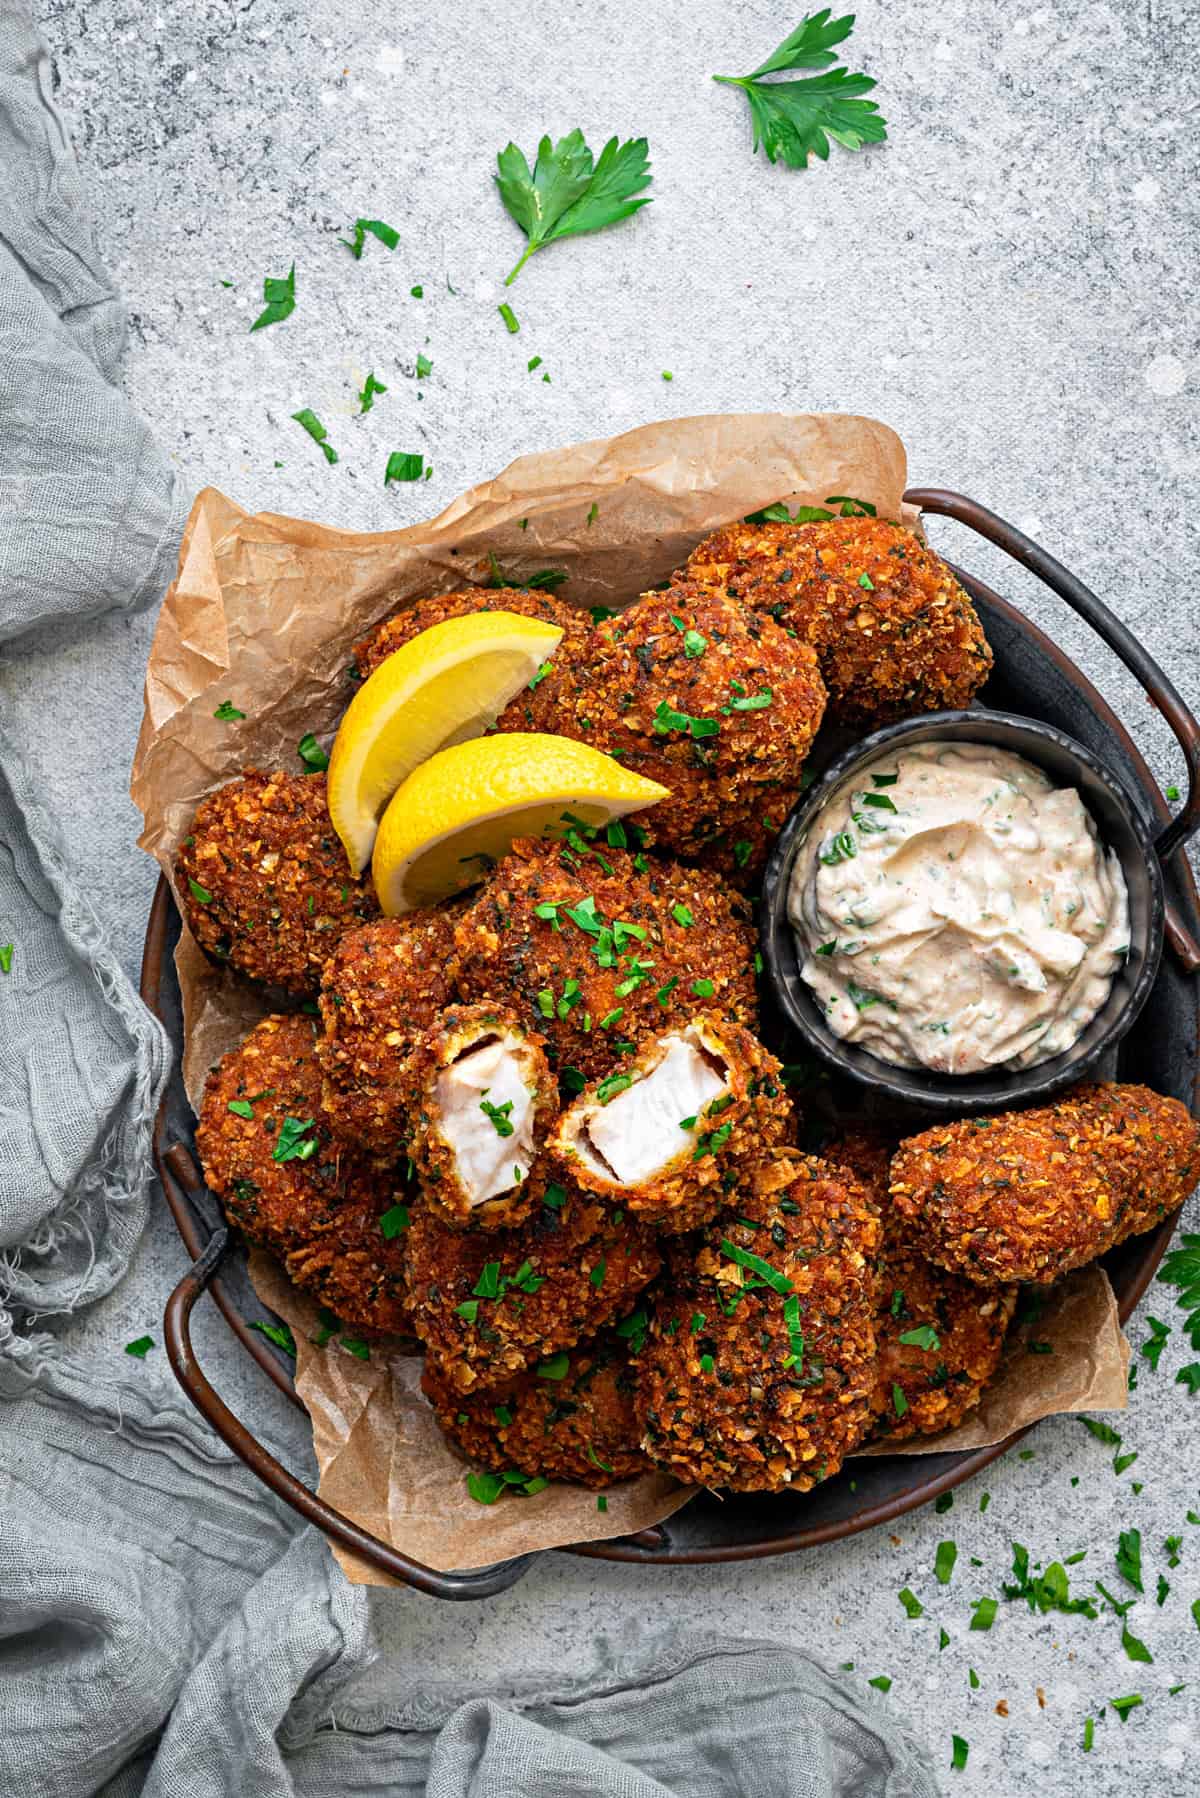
left=421, top=1329, right=649, bottom=1491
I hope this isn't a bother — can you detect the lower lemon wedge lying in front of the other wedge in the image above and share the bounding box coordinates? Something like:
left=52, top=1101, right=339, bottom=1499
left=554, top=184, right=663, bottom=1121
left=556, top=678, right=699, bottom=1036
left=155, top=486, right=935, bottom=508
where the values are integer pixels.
left=371, top=732, right=669, bottom=917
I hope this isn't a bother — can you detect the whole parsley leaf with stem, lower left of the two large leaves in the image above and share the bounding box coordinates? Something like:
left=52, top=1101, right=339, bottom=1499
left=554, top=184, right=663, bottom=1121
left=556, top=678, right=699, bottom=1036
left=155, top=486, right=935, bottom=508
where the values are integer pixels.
left=497, top=129, right=651, bottom=288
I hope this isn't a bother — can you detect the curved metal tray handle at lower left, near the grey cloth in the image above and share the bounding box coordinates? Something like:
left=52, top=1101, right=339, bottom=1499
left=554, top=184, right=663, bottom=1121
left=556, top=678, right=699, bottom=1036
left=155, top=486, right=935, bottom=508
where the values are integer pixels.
left=162, top=1228, right=534, bottom=1598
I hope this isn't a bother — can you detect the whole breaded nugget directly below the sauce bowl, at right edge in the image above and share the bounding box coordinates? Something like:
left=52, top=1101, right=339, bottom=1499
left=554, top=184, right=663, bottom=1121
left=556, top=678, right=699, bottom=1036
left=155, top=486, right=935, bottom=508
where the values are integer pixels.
left=889, top=1084, right=1200, bottom=1286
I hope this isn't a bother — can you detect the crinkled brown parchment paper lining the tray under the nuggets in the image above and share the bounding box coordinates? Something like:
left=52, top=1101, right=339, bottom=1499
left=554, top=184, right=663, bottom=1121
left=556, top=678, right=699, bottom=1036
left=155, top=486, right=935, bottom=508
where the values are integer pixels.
left=131, top=412, right=1128, bottom=1584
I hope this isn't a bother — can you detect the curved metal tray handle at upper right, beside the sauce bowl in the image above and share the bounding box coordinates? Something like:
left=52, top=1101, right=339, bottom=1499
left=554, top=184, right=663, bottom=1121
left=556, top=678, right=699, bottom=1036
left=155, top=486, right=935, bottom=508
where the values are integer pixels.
left=905, top=487, right=1200, bottom=861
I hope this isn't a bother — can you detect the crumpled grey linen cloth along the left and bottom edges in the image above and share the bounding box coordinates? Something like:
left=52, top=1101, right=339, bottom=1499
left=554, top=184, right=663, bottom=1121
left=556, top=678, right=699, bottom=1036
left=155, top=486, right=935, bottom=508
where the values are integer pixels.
left=0, top=0, right=936, bottom=1798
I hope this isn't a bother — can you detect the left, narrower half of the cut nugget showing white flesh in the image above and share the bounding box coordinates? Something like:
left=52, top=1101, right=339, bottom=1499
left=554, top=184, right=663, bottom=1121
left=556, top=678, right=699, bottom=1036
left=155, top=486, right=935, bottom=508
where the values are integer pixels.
left=399, top=1005, right=558, bottom=1230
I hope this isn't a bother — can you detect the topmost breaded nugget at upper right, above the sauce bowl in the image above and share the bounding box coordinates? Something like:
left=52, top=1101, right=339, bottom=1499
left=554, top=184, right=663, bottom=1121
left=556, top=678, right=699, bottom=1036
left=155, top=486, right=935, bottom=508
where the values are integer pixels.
left=684, top=518, right=991, bottom=728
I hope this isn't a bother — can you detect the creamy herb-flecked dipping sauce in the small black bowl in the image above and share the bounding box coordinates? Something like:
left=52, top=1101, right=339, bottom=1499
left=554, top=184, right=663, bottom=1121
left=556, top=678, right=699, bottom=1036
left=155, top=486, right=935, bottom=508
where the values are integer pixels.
left=788, top=743, right=1130, bottom=1073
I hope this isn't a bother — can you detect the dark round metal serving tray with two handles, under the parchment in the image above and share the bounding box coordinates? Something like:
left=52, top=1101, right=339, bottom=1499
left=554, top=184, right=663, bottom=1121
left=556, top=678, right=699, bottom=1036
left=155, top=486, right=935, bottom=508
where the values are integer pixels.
left=142, top=489, right=1200, bottom=1598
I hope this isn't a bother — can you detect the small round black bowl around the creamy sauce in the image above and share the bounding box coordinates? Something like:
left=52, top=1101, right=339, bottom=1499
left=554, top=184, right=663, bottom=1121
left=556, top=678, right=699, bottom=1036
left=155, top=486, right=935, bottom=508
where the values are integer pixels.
left=761, top=708, right=1164, bottom=1111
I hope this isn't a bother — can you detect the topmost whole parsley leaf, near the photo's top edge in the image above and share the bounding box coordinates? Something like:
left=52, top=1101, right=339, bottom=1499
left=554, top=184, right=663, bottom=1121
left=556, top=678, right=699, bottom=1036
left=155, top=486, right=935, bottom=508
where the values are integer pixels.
left=712, top=7, right=887, bottom=169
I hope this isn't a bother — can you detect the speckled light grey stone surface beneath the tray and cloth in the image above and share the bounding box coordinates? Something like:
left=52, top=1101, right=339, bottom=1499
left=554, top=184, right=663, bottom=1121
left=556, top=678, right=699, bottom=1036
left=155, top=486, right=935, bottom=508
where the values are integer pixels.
left=0, top=0, right=1200, bottom=1798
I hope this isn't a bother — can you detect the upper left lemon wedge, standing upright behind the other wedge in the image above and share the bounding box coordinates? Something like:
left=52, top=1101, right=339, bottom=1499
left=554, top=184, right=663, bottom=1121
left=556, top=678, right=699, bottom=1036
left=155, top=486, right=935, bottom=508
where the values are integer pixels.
left=326, top=611, right=563, bottom=874
